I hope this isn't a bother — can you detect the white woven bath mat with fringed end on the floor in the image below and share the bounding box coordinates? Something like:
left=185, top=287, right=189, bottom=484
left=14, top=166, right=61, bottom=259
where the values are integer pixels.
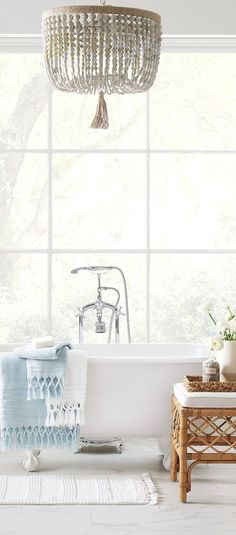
left=0, top=473, right=158, bottom=505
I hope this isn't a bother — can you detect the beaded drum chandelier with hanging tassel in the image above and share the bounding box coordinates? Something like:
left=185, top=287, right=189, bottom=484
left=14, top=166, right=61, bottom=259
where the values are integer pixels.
left=42, top=0, right=161, bottom=128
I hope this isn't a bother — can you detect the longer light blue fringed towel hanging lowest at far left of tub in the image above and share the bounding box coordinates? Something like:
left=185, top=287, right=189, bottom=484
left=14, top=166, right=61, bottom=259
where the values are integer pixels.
left=0, top=353, right=79, bottom=450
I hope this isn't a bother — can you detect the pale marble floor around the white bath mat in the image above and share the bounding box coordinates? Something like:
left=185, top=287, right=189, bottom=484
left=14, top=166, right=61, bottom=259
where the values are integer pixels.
left=0, top=439, right=236, bottom=535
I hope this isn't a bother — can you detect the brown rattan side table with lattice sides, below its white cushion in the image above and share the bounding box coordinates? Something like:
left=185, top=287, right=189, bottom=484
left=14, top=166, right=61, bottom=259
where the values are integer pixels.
left=171, top=396, right=236, bottom=502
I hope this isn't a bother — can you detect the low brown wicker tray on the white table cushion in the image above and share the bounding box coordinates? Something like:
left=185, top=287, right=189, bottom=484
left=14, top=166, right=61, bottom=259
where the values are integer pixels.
left=183, top=375, right=236, bottom=392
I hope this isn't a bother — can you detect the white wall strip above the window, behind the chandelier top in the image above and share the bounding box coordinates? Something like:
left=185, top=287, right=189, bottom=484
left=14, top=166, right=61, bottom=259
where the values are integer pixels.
left=0, top=0, right=236, bottom=34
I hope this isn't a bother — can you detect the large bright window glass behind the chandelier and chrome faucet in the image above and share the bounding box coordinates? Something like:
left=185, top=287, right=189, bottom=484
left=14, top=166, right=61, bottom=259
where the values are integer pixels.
left=0, top=53, right=236, bottom=343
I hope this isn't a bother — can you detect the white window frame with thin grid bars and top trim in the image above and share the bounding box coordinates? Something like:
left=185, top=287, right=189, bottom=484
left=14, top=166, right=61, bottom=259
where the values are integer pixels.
left=0, top=34, right=236, bottom=343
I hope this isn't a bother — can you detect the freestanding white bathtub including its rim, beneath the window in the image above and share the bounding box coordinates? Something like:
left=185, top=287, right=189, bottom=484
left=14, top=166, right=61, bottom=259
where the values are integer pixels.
left=78, top=344, right=207, bottom=437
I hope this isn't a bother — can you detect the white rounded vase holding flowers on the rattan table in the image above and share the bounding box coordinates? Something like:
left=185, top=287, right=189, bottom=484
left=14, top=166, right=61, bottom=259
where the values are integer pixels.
left=217, top=340, right=236, bottom=381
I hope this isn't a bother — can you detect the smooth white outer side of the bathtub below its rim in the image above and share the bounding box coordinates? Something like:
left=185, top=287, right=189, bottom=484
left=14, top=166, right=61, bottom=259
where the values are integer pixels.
left=82, top=361, right=201, bottom=437
